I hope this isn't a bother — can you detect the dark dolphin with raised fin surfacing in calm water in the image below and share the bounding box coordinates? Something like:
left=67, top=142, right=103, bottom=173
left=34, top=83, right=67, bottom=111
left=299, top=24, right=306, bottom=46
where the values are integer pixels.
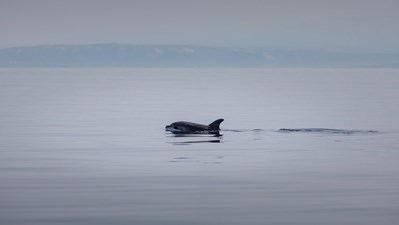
left=165, top=119, right=224, bottom=135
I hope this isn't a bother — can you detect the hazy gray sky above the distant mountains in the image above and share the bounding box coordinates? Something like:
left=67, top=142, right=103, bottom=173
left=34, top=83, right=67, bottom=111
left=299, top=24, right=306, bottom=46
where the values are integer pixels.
left=0, top=0, right=399, bottom=52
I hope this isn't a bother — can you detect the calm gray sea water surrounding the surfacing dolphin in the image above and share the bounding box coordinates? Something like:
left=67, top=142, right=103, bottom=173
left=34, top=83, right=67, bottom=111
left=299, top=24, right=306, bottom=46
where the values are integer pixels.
left=0, top=69, right=399, bottom=225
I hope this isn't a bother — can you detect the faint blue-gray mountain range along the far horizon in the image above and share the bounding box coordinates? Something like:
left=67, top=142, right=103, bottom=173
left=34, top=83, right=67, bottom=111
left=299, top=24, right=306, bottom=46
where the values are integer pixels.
left=0, top=44, right=399, bottom=68
